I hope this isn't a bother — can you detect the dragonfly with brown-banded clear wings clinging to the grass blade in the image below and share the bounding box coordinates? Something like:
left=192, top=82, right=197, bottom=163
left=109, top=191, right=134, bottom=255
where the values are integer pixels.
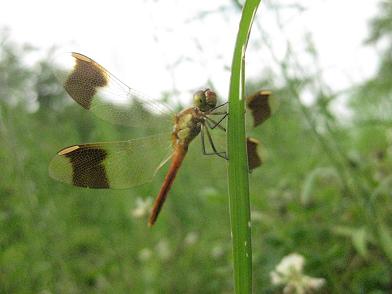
left=49, top=52, right=269, bottom=226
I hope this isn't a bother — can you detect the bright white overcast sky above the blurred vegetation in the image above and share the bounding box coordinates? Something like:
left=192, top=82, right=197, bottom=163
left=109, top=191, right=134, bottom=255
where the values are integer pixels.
left=0, top=0, right=378, bottom=104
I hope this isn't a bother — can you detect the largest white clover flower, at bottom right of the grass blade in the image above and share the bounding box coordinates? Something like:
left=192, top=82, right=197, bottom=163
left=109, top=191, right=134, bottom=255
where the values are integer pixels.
left=270, top=253, right=325, bottom=294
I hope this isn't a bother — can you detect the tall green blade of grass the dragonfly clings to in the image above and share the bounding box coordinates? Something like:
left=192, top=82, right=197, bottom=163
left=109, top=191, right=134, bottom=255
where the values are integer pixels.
left=227, top=0, right=260, bottom=293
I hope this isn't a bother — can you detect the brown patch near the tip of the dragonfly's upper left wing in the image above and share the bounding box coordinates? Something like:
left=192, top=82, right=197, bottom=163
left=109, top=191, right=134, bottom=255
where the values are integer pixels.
left=64, top=52, right=108, bottom=109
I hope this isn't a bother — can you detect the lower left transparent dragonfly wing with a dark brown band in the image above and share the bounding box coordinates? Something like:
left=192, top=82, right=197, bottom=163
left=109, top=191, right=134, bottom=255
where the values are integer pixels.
left=49, top=133, right=171, bottom=189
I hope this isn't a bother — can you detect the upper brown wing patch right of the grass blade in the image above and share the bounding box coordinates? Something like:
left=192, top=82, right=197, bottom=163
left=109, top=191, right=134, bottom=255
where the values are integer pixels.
left=246, top=90, right=272, bottom=127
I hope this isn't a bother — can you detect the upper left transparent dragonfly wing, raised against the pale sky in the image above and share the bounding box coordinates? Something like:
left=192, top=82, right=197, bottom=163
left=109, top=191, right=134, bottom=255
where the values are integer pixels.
left=55, top=52, right=173, bottom=127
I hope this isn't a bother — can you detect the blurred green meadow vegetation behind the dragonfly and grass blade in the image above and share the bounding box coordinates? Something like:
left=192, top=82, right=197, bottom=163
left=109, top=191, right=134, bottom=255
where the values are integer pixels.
left=0, top=1, right=392, bottom=293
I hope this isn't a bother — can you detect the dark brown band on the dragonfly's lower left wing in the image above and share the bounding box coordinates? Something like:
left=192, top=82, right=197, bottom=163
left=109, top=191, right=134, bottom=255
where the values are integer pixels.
left=64, top=146, right=110, bottom=188
